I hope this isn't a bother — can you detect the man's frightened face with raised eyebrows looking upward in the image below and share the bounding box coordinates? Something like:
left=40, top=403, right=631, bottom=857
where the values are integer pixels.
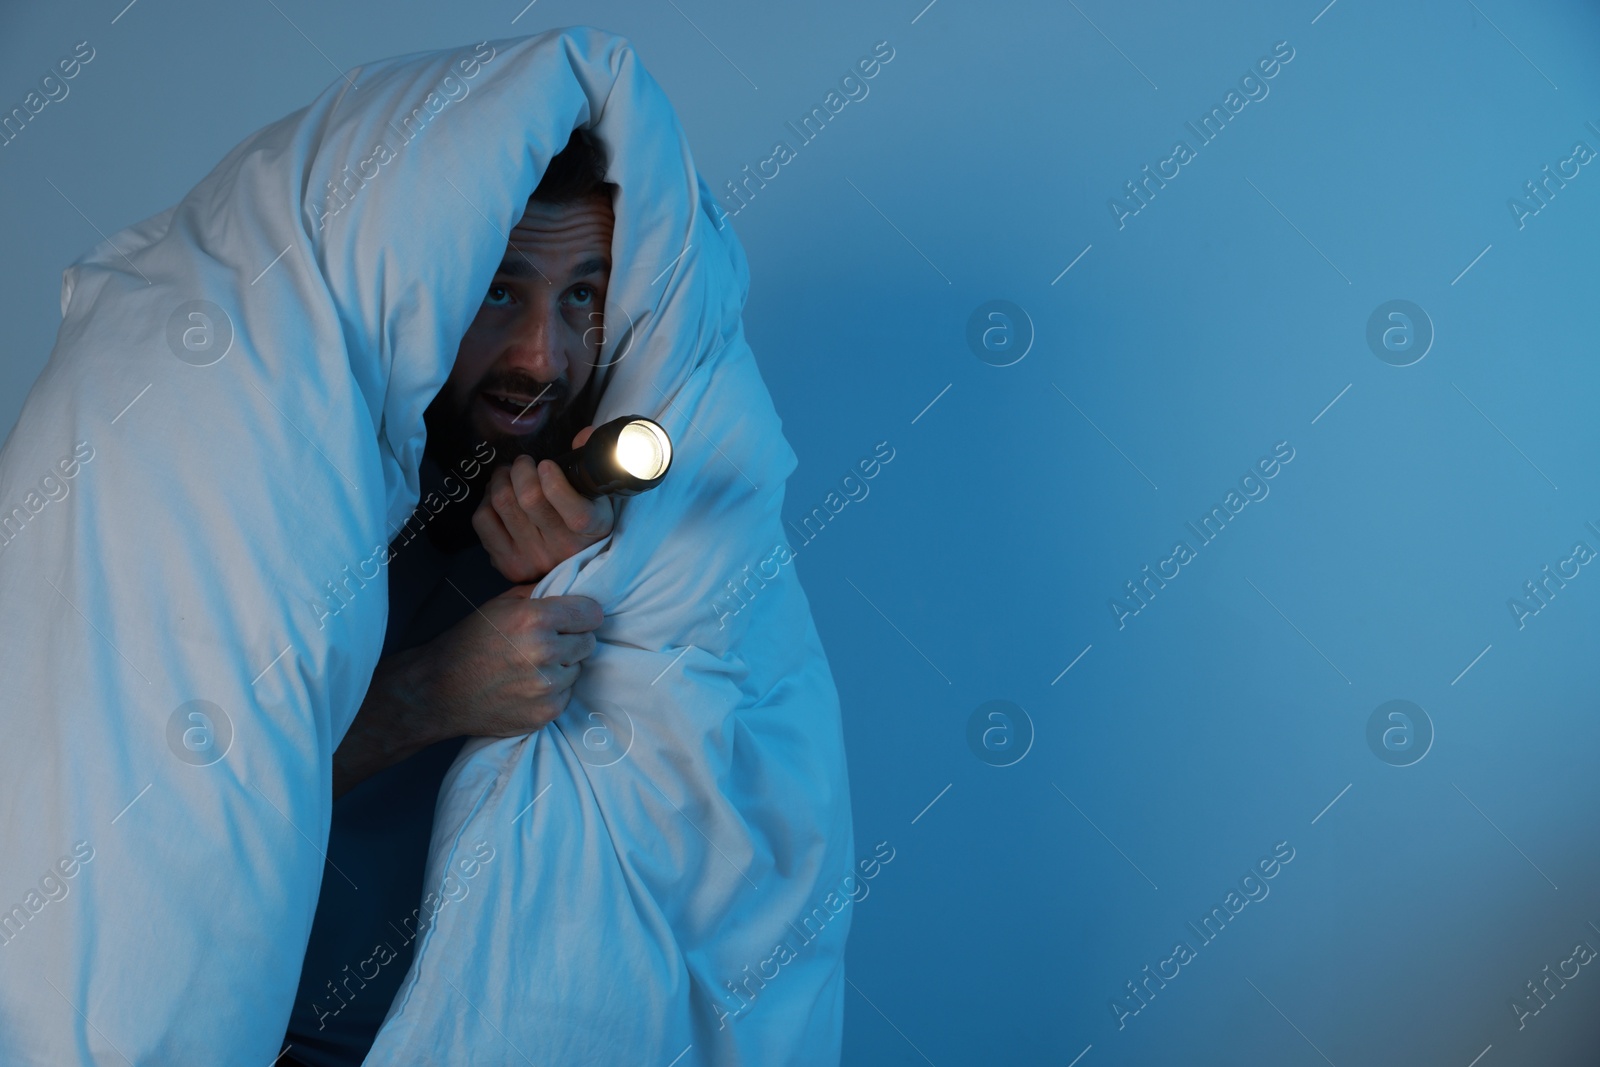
left=429, top=195, right=613, bottom=459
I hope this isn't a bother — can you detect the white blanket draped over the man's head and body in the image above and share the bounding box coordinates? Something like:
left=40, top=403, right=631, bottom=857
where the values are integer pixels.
left=0, top=27, right=854, bottom=1067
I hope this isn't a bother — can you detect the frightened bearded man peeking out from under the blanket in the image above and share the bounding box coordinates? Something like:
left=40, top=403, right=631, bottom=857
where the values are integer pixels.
left=283, top=130, right=614, bottom=1067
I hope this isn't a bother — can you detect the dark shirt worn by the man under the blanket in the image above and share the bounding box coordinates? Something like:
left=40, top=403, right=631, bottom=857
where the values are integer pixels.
left=283, top=461, right=510, bottom=1067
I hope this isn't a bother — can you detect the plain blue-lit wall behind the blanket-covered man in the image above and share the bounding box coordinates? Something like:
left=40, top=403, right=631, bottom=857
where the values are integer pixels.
left=0, top=0, right=1600, bottom=1067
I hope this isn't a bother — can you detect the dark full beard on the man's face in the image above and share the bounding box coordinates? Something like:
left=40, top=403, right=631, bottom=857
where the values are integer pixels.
left=422, top=371, right=595, bottom=553
